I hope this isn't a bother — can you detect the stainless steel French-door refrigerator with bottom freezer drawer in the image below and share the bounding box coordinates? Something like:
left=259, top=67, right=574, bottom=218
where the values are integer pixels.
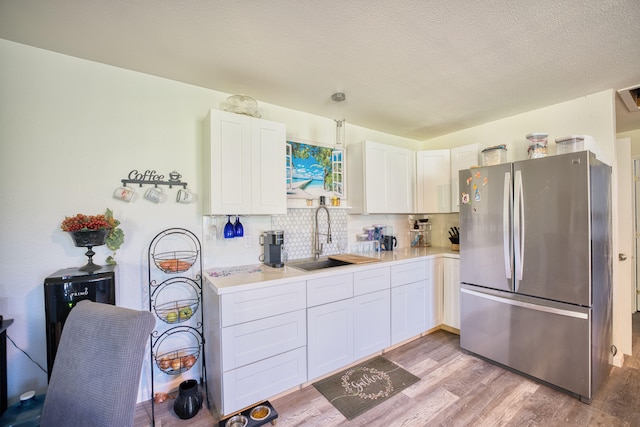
left=459, top=151, right=613, bottom=403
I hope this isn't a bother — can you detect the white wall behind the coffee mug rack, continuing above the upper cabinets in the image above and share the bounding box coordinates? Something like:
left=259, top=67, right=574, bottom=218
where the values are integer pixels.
left=0, top=39, right=418, bottom=403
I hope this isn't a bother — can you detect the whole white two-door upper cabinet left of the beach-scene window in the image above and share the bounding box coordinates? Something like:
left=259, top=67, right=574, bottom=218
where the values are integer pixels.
left=203, top=110, right=287, bottom=215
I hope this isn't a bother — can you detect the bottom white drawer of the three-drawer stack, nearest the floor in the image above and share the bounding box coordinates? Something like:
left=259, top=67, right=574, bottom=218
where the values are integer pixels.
left=220, top=347, right=307, bottom=416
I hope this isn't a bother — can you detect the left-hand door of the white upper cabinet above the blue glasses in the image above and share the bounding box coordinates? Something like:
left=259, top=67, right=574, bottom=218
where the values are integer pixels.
left=203, top=110, right=251, bottom=214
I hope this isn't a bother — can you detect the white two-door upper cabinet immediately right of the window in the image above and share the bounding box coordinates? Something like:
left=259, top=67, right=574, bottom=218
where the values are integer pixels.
left=347, top=141, right=415, bottom=214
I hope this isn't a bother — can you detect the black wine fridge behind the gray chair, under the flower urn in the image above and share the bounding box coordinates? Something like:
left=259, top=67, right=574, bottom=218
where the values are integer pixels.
left=44, top=265, right=116, bottom=379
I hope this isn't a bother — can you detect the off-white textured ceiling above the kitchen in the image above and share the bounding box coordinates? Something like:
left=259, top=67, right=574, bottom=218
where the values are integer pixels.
left=0, top=0, right=640, bottom=140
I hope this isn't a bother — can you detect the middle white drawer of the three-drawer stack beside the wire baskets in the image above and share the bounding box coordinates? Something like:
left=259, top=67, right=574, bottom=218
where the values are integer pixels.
left=222, top=310, right=307, bottom=372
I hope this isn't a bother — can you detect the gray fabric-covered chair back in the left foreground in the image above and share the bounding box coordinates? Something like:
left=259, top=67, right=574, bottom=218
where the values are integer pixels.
left=40, top=300, right=155, bottom=427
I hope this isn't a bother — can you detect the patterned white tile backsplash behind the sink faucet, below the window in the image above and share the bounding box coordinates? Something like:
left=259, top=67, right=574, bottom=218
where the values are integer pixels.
left=271, top=207, right=347, bottom=260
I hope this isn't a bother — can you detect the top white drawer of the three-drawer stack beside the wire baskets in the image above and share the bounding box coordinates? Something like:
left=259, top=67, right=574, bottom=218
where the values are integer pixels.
left=220, top=281, right=307, bottom=327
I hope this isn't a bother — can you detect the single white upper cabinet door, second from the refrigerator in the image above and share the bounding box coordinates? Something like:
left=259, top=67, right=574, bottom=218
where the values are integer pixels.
left=416, top=150, right=451, bottom=213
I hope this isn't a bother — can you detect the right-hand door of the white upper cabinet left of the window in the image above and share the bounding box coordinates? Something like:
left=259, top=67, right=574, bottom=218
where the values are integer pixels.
left=251, top=119, right=287, bottom=215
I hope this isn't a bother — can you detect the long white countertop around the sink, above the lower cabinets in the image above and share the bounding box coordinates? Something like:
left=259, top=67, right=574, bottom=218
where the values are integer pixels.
left=204, top=247, right=460, bottom=295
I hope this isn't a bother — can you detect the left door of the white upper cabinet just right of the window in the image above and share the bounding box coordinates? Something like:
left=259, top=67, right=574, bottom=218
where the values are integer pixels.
left=364, top=141, right=389, bottom=213
